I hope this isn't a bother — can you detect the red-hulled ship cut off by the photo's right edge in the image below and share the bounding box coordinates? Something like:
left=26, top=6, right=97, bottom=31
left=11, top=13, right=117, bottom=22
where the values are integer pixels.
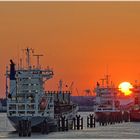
left=130, top=85, right=140, bottom=122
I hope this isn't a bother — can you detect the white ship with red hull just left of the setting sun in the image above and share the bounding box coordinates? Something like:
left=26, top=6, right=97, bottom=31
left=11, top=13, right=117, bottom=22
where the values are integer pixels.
left=94, top=75, right=120, bottom=120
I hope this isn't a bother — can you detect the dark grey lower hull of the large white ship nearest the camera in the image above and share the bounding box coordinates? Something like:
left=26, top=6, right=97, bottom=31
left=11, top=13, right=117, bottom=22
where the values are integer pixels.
left=8, top=107, right=78, bottom=132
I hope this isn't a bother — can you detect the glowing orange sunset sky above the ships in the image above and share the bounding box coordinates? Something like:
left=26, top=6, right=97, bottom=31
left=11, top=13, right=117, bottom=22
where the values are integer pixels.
left=0, top=2, right=140, bottom=97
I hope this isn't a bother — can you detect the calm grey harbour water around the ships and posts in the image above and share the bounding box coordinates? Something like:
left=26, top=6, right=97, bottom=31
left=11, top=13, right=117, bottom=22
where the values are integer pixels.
left=0, top=112, right=140, bottom=139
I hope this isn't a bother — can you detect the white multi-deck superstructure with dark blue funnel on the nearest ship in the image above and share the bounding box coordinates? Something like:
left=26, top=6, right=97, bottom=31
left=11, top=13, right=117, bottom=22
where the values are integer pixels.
left=7, top=60, right=54, bottom=117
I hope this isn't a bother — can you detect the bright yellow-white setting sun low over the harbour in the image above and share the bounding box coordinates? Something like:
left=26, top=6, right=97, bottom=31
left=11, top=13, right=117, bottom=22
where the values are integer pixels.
left=119, top=82, right=133, bottom=96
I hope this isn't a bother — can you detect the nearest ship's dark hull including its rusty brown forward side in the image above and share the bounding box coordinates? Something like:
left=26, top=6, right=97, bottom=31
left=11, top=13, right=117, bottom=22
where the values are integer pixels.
left=8, top=104, right=78, bottom=132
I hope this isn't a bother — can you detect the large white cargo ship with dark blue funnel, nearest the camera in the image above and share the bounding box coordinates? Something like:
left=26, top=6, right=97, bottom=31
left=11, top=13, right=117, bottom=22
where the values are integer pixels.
left=6, top=48, right=78, bottom=136
